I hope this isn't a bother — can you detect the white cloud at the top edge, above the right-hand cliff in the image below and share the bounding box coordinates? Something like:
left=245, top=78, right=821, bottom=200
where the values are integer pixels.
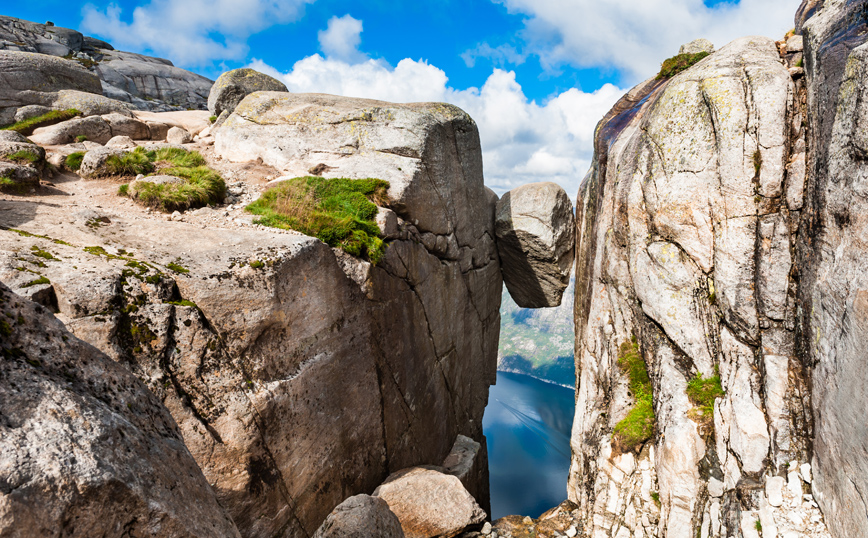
left=495, top=0, right=800, bottom=81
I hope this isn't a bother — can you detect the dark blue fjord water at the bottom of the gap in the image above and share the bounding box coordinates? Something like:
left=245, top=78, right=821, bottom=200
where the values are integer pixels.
left=482, top=372, right=575, bottom=519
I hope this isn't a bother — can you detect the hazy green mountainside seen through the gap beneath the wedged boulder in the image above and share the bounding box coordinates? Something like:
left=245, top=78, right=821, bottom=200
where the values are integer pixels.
left=497, top=276, right=576, bottom=387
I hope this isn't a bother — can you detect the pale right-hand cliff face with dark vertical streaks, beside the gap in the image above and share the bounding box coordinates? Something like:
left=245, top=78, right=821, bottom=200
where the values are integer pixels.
left=569, top=37, right=828, bottom=538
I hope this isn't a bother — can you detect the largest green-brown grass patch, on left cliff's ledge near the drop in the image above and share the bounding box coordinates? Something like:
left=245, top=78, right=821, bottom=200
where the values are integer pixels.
left=247, top=176, right=389, bottom=264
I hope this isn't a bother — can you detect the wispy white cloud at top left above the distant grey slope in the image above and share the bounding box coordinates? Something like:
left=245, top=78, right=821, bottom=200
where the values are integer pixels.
left=81, top=0, right=314, bottom=66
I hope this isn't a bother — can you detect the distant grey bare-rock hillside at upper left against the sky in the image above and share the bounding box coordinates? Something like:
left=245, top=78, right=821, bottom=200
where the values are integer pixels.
left=0, top=15, right=212, bottom=114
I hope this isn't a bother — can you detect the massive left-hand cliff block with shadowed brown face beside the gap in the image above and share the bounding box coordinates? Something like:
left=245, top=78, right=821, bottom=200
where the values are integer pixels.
left=0, top=94, right=502, bottom=537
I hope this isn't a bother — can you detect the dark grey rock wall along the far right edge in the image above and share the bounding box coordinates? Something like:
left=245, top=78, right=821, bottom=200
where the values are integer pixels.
left=795, top=0, right=868, bottom=538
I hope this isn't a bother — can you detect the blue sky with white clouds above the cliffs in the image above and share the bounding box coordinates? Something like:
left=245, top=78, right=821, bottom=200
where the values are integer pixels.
left=0, top=0, right=800, bottom=194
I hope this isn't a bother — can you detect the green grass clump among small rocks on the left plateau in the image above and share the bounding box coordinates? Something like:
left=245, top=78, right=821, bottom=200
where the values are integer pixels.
left=118, top=148, right=226, bottom=212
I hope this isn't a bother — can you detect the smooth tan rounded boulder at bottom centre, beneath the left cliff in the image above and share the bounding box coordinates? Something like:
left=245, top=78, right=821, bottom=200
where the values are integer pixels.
left=374, top=467, right=486, bottom=538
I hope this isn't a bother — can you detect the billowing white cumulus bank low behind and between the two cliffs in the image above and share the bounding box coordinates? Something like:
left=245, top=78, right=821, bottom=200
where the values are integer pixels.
left=250, top=48, right=623, bottom=197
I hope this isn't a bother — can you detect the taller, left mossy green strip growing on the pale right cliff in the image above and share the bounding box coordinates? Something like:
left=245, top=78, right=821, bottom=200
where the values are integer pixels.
left=615, top=337, right=656, bottom=452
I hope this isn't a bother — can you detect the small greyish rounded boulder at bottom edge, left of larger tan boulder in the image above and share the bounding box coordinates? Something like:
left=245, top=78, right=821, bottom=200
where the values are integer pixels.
left=313, top=494, right=404, bottom=538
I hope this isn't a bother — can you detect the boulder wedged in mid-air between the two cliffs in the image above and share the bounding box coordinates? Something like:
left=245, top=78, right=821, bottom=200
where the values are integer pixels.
left=495, top=182, right=575, bottom=308
